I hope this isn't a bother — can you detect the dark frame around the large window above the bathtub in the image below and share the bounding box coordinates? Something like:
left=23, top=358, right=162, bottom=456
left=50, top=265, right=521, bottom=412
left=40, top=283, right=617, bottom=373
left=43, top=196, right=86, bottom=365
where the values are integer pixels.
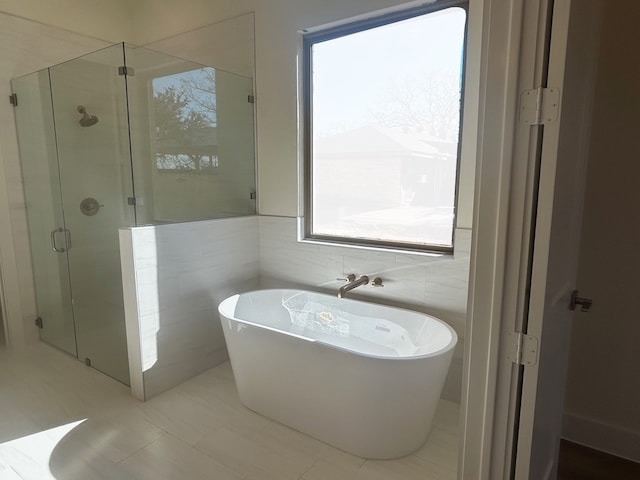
left=301, top=0, right=469, bottom=254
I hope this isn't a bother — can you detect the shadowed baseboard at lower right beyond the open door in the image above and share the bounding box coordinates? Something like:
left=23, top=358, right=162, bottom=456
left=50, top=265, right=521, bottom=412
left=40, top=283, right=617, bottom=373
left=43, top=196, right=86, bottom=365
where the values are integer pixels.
left=562, top=412, right=640, bottom=463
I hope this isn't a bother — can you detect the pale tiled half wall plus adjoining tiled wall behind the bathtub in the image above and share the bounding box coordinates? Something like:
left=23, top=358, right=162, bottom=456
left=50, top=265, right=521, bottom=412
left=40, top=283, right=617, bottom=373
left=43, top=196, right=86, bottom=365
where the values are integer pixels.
left=121, top=216, right=471, bottom=401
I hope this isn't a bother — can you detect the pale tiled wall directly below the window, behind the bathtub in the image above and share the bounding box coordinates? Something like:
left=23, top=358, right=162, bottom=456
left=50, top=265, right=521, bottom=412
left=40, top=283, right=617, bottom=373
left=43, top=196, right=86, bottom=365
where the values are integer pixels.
left=260, top=216, right=471, bottom=402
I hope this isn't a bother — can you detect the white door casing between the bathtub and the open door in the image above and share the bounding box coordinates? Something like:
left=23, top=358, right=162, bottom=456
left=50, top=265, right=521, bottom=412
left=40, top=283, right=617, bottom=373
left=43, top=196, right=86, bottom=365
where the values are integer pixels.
left=458, top=0, right=550, bottom=480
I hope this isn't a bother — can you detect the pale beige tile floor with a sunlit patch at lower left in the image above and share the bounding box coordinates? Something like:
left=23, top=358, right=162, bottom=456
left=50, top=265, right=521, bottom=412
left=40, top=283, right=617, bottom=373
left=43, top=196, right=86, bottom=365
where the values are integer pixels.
left=0, top=345, right=458, bottom=480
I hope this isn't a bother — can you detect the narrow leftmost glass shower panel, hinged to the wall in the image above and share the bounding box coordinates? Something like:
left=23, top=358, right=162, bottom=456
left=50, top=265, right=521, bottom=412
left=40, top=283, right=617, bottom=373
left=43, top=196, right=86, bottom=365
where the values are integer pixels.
left=11, top=70, right=77, bottom=356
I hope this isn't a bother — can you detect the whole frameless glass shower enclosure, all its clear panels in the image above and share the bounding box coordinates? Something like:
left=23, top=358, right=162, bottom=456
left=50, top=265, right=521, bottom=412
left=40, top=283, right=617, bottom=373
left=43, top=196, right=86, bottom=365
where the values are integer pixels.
left=11, top=44, right=255, bottom=384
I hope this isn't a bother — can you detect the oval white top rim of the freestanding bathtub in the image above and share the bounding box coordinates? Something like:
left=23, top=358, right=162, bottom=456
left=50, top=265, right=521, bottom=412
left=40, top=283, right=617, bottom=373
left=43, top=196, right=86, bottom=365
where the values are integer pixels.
left=218, top=288, right=459, bottom=361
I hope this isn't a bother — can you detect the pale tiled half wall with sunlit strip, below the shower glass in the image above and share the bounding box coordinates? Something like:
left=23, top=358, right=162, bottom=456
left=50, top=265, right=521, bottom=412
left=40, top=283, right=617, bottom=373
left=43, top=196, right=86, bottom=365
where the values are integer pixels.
left=120, top=216, right=259, bottom=400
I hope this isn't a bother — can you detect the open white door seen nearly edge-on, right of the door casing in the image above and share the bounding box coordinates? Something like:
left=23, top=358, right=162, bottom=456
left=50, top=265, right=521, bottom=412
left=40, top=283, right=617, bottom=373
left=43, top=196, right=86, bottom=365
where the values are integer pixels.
left=514, top=0, right=602, bottom=479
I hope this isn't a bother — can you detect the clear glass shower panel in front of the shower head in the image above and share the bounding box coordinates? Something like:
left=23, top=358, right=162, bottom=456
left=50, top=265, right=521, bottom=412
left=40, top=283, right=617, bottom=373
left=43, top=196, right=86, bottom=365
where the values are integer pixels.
left=49, top=45, right=135, bottom=384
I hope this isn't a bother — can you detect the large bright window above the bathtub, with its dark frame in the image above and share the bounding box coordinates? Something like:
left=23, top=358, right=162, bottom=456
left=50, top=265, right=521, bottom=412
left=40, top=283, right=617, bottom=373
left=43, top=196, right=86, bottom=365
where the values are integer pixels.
left=303, top=2, right=467, bottom=252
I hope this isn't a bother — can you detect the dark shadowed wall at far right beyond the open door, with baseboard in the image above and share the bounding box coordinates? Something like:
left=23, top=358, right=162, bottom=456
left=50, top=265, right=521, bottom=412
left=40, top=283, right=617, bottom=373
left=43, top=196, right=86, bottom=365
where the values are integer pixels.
left=563, top=0, right=640, bottom=462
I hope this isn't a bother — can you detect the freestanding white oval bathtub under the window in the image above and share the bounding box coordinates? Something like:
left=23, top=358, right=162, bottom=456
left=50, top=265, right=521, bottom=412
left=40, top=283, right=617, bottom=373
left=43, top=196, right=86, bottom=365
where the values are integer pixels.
left=218, top=290, right=457, bottom=459
